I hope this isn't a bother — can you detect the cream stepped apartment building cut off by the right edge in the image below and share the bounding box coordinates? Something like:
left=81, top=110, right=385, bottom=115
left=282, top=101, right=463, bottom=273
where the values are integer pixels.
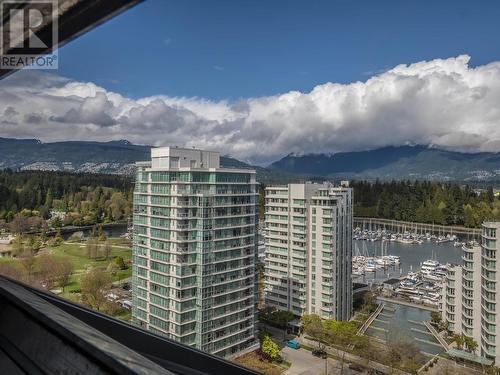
left=441, top=222, right=500, bottom=365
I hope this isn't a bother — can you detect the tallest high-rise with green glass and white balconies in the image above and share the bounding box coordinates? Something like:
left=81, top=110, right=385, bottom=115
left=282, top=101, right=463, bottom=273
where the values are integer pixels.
left=132, top=147, right=257, bottom=356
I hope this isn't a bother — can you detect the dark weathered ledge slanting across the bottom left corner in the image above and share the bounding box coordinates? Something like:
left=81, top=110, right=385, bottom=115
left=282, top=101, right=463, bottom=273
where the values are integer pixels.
left=0, top=276, right=257, bottom=375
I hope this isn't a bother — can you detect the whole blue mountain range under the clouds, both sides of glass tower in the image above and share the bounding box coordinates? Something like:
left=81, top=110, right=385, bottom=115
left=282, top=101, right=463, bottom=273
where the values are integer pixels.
left=0, top=138, right=500, bottom=183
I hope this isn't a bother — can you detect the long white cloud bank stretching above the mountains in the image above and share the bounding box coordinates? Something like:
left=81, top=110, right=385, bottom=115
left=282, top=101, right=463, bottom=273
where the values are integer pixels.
left=0, top=56, right=500, bottom=162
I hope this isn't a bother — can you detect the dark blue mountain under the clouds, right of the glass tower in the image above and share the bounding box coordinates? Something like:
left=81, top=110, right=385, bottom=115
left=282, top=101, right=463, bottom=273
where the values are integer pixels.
left=269, top=145, right=500, bottom=181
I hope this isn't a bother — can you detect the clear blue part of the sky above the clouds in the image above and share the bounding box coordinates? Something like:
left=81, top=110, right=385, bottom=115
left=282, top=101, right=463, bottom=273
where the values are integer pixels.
left=59, top=0, right=500, bottom=100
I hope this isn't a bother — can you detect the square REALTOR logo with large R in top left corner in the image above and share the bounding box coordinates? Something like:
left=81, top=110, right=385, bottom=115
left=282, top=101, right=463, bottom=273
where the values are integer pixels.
left=0, top=0, right=58, bottom=69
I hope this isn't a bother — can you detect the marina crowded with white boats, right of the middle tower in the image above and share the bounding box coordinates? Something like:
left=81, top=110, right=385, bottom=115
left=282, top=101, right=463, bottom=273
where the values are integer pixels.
left=352, top=228, right=464, bottom=312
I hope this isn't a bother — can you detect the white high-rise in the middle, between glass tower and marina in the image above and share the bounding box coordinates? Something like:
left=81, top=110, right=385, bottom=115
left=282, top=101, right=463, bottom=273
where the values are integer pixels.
left=265, top=181, right=353, bottom=320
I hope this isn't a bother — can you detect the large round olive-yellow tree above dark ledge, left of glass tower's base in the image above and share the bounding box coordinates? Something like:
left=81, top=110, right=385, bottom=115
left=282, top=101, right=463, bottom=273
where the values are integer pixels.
left=81, top=268, right=111, bottom=311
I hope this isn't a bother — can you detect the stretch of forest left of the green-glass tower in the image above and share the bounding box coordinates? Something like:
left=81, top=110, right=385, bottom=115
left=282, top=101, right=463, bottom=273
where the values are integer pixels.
left=0, top=170, right=132, bottom=229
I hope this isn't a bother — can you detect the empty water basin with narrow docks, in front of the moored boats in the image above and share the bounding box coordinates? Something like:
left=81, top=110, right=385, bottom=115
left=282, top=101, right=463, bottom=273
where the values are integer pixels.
left=366, top=302, right=444, bottom=355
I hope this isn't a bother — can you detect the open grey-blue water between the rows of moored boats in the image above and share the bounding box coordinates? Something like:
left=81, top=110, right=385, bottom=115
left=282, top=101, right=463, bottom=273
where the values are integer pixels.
left=353, top=240, right=462, bottom=283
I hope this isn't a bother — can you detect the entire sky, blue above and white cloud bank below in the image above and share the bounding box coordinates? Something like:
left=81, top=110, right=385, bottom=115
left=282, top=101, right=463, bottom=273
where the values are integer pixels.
left=5, top=0, right=500, bottom=164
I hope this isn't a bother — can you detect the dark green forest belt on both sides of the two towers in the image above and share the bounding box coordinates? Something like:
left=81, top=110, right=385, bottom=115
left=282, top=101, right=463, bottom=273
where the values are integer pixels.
left=0, top=170, right=500, bottom=229
